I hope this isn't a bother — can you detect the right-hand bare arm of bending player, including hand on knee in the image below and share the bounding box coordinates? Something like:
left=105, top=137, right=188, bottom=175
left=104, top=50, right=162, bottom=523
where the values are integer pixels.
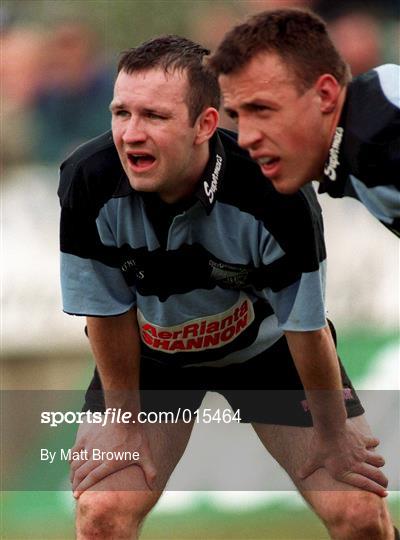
left=286, top=327, right=387, bottom=496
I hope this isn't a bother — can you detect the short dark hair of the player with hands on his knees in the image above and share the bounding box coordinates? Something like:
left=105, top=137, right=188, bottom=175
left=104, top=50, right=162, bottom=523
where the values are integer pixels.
left=118, top=35, right=220, bottom=125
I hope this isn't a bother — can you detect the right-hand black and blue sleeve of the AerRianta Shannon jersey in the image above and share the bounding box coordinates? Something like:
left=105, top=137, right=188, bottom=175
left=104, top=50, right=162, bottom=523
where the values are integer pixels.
left=255, top=187, right=327, bottom=332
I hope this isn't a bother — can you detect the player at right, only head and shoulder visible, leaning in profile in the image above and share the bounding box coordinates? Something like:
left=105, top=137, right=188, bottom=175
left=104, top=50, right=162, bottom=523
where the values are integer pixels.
left=211, top=9, right=400, bottom=235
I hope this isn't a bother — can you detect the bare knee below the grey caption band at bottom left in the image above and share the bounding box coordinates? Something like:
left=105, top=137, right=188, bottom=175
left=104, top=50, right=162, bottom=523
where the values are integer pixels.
left=76, top=491, right=154, bottom=540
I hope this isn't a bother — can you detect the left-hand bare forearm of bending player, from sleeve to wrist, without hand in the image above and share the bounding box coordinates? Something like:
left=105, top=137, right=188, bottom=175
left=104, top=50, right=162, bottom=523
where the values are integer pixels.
left=87, top=310, right=140, bottom=411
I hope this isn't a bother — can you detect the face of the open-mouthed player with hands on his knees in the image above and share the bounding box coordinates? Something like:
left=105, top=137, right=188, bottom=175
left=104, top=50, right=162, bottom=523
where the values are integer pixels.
left=110, top=69, right=197, bottom=202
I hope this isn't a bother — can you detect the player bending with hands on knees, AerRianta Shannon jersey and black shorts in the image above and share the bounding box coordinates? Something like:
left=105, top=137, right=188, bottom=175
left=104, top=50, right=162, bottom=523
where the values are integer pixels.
left=59, top=36, right=392, bottom=540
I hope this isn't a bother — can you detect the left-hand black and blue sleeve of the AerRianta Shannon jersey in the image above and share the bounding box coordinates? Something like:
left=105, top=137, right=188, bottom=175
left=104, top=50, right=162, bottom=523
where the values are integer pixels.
left=59, top=156, right=136, bottom=317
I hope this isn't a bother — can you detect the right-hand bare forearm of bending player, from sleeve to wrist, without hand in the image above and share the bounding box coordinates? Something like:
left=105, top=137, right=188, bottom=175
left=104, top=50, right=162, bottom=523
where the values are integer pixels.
left=286, top=327, right=347, bottom=432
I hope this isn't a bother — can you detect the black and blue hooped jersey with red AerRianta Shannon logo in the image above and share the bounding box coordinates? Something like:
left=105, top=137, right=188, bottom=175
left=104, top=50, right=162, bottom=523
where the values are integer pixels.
left=59, top=130, right=326, bottom=366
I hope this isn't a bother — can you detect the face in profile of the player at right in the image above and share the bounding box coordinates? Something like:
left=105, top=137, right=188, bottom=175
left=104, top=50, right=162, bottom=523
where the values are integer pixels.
left=219, top=53, right=330, bottom=193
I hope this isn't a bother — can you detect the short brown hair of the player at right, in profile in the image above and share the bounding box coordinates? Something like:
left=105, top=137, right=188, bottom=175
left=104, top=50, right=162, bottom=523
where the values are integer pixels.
left=209, top=9, right=351, bottom=91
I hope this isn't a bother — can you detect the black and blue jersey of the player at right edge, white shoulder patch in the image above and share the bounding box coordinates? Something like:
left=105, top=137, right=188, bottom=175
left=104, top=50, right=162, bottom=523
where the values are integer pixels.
left=319, top=64, right=400, bottom=236
